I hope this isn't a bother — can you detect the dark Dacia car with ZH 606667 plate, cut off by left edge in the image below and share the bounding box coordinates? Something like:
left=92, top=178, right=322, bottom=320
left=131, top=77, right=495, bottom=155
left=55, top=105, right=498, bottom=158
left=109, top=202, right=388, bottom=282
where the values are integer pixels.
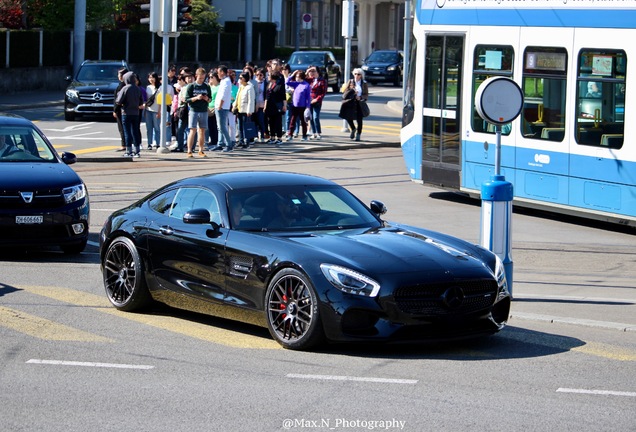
left=0, top=113, right=90, bottom=253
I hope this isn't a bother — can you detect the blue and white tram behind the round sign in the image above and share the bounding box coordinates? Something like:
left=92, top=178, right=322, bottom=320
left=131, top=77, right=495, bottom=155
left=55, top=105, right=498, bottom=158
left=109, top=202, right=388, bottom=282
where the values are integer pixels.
left=401, top=0, right=636, bottom=226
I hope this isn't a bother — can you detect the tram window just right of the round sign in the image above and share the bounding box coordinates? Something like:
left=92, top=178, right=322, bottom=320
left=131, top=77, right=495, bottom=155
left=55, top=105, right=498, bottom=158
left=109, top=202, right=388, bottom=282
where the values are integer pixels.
left=521, top=47, right=568, bottom=142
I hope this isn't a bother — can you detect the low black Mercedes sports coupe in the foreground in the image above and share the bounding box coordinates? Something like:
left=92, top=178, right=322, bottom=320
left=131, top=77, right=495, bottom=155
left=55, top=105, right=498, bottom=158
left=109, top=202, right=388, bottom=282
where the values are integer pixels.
left=100, top=172, right=511, bottom=349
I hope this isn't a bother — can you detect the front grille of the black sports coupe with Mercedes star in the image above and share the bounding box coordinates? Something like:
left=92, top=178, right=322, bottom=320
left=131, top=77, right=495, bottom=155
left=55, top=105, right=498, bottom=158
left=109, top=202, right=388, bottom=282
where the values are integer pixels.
left=394, top=280, right=497, bottom=317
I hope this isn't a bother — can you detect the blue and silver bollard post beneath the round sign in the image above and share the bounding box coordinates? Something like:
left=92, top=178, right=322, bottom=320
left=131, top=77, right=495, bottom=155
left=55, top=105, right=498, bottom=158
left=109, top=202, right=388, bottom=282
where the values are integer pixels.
left=480, top=175, right=513, bottom=297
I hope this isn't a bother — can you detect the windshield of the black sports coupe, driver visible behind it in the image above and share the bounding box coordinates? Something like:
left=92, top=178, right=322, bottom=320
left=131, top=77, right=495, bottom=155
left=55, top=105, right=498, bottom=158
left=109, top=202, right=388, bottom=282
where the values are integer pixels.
left=228, top=185, right=380, bottom=231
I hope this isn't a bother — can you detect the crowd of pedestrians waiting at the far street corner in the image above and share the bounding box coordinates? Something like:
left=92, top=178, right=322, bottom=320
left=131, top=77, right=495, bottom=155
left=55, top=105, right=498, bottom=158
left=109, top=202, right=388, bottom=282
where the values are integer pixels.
left=113, top=59, right=368, bottom=158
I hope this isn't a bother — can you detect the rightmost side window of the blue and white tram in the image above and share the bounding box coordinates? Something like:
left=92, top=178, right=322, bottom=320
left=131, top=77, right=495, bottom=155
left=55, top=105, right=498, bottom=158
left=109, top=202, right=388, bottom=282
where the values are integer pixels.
left=575, top=49, right=627, bottom=149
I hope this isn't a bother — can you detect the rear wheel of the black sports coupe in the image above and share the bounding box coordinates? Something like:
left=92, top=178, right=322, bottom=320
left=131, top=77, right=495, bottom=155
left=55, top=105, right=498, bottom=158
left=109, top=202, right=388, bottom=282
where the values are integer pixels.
left=102, top=237, right=151, bottom=312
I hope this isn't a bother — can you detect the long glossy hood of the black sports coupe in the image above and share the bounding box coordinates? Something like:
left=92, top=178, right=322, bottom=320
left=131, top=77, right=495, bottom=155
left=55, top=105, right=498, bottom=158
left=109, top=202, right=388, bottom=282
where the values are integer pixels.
left=276, top=226, right=485, bottom=274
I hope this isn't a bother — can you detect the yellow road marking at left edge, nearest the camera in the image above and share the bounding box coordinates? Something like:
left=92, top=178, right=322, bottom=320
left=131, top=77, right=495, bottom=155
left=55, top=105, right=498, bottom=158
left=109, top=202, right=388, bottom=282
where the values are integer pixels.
left=0, top=306, right=113, bottom=342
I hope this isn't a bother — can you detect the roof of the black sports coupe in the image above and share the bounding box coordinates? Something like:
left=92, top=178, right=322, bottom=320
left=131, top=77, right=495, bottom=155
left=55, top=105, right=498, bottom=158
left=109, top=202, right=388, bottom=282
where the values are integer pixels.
left=178, top=171, right=336, bottom=190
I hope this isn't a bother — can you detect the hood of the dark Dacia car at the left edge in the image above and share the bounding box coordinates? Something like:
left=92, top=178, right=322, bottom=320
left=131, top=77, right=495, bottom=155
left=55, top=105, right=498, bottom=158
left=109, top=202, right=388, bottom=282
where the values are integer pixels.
left=0, top=162, right=82, bottom=190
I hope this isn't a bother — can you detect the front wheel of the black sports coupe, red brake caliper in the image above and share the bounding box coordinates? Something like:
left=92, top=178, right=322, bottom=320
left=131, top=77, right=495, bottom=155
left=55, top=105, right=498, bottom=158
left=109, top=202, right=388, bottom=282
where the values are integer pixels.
left=265, top=268, right=324, bottom=350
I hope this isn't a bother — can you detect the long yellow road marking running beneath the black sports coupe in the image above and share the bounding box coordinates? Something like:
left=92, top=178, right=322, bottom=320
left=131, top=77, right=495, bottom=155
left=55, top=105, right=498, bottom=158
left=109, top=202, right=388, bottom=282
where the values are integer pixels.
left=16, top=286, right=281, bottom=349
